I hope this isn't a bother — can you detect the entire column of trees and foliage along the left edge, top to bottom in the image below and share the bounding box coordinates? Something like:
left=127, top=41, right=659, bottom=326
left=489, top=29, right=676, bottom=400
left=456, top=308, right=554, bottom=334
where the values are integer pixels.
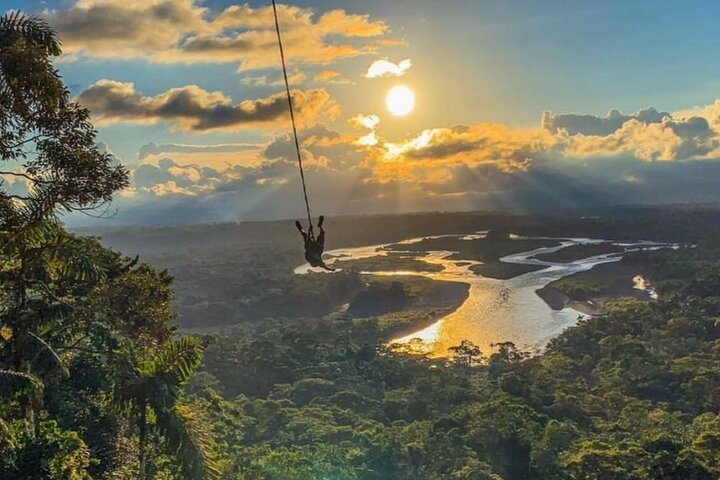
left=0, top=12, right=220, bottom=480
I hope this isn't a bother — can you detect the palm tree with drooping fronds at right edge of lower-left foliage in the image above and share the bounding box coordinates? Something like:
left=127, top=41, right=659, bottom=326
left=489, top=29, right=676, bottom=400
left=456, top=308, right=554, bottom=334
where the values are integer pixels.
left=113, top=337, right=220, bottom=480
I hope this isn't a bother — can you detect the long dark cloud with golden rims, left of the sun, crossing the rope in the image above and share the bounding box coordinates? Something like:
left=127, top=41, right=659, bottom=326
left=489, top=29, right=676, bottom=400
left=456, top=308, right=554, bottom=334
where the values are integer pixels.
left=77, top=80, right=340, bottom=131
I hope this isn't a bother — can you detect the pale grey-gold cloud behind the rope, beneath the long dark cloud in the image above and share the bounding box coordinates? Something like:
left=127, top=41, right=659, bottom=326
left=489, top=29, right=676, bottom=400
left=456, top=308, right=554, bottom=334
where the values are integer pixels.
left=122, top=125, right=363, bottom=204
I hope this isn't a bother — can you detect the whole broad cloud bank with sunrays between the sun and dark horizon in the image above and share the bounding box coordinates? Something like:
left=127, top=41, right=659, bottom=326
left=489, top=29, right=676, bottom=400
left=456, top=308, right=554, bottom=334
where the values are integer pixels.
left=66, top=96, right=720, bottom=227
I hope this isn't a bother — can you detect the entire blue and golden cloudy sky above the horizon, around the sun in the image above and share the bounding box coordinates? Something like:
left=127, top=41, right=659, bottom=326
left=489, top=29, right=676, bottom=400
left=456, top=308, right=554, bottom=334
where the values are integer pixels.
left=8, top=0, right=720, bottom=225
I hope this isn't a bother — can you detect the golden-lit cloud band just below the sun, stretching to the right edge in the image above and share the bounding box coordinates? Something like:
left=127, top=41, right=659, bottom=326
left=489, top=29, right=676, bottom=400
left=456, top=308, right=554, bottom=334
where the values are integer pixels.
left=125, top=100, right=719, bottom=200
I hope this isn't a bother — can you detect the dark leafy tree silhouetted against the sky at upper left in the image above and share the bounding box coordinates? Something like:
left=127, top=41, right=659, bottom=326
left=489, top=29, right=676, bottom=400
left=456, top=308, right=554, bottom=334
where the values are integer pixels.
left=0, top=12, right=128, bottom=223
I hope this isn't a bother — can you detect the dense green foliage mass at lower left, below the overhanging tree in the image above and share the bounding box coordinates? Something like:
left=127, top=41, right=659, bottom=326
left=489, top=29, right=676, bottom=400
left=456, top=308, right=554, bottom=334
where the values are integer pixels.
left=0, top=222, right=219, bottom=480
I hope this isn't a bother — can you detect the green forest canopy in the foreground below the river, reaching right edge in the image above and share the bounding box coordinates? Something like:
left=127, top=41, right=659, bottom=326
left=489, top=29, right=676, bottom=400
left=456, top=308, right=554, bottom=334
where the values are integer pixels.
left=194, top=244, right=720, bottom=480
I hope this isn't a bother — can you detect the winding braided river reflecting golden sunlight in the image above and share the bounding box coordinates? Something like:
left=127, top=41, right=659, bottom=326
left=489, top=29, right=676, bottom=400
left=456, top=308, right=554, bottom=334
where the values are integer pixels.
left=295, top=232, right=668, bottom=356
